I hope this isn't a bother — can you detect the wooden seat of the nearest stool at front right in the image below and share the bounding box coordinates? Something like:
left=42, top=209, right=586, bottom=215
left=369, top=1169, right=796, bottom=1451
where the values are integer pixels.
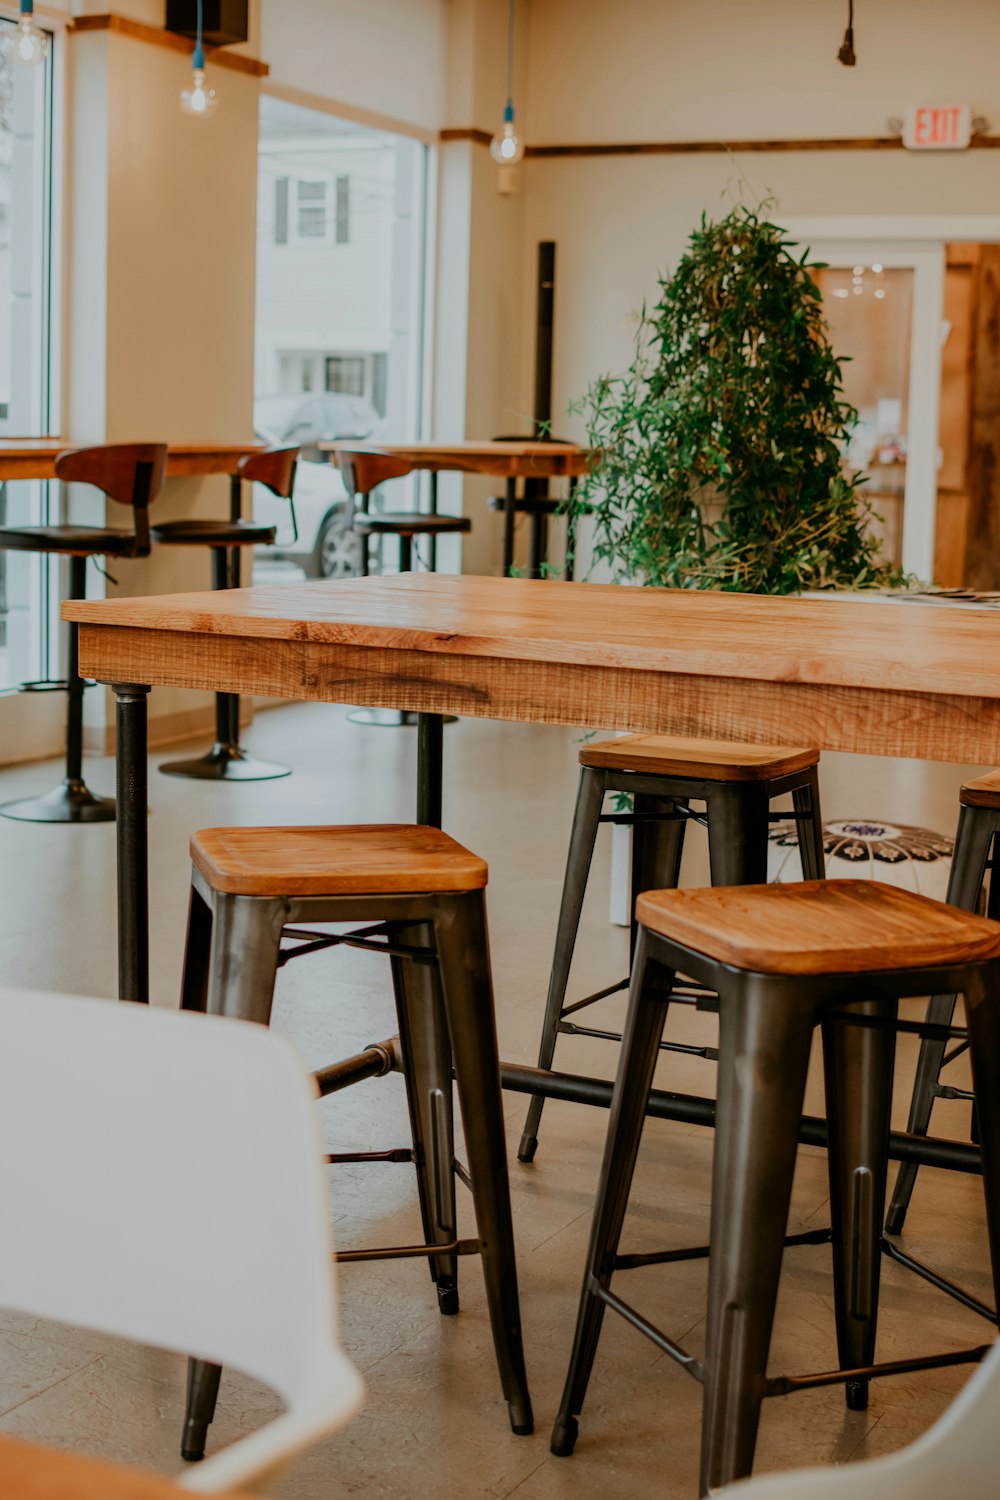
left=636, top=881, right=1000, bottom=974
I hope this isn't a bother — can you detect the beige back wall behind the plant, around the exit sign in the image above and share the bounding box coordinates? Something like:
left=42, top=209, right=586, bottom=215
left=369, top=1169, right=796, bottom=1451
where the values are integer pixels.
left=520, top=0, right=1000, bottom=432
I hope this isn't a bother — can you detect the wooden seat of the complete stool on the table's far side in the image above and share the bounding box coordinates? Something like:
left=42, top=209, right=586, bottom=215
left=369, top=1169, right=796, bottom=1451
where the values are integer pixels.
left=580, top=735, right=820, bottom=782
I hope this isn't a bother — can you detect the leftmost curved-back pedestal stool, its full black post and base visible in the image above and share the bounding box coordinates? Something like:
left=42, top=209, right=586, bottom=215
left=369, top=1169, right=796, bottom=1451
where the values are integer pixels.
left=0, top=443, right=166, bottom=824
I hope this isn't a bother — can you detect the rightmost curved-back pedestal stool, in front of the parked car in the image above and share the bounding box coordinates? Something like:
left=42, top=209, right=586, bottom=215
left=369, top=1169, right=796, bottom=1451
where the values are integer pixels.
left=336, top=447, right=471, bottom=729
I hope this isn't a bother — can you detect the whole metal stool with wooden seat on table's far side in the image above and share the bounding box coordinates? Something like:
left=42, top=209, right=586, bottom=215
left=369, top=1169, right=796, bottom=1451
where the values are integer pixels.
left=517, top=735, right=825, bottom=1161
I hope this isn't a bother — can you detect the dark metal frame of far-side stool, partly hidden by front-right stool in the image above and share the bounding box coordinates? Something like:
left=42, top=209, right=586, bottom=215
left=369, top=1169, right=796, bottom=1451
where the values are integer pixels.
left=517, top=765, right=825, bottom=1161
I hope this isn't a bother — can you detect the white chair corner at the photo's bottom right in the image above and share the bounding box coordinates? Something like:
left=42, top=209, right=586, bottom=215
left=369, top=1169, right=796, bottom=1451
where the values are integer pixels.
left=715, top=1344, right=1000, bottom=1500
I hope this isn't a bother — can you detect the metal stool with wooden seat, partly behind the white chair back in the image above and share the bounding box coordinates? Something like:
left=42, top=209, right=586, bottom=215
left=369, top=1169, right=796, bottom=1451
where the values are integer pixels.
left=173, top=825, right=532, bottom=1458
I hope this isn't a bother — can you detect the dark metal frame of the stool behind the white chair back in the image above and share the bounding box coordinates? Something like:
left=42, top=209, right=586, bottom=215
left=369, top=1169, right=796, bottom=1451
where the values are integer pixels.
left=181, top=869, right=532, bottom=1460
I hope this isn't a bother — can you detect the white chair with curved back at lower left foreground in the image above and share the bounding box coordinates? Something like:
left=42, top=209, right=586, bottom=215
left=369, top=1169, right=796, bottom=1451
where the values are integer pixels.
left=0, top=989, right=364, bottom=1494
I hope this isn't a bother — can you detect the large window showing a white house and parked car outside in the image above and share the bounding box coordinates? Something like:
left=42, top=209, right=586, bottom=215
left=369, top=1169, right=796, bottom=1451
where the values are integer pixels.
left=253, top=92, right=429, bottom=579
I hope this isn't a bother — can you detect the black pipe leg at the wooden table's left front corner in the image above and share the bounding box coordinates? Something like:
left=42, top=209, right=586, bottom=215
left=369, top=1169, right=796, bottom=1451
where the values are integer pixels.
left=112, top=683, right=150, bottom=1005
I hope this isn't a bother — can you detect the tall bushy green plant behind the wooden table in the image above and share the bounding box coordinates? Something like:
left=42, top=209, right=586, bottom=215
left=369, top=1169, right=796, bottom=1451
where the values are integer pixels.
left=568, top=206, right=901, bottom=594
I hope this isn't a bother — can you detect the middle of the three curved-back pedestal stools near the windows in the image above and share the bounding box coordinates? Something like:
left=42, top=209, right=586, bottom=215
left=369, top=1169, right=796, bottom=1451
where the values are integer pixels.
left=153, top=449, right=298, bottom=782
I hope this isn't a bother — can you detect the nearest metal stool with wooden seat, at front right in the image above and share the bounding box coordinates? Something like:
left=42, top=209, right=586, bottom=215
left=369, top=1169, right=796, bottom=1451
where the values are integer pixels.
left=552, top=881, right=1000, bottom=1494
